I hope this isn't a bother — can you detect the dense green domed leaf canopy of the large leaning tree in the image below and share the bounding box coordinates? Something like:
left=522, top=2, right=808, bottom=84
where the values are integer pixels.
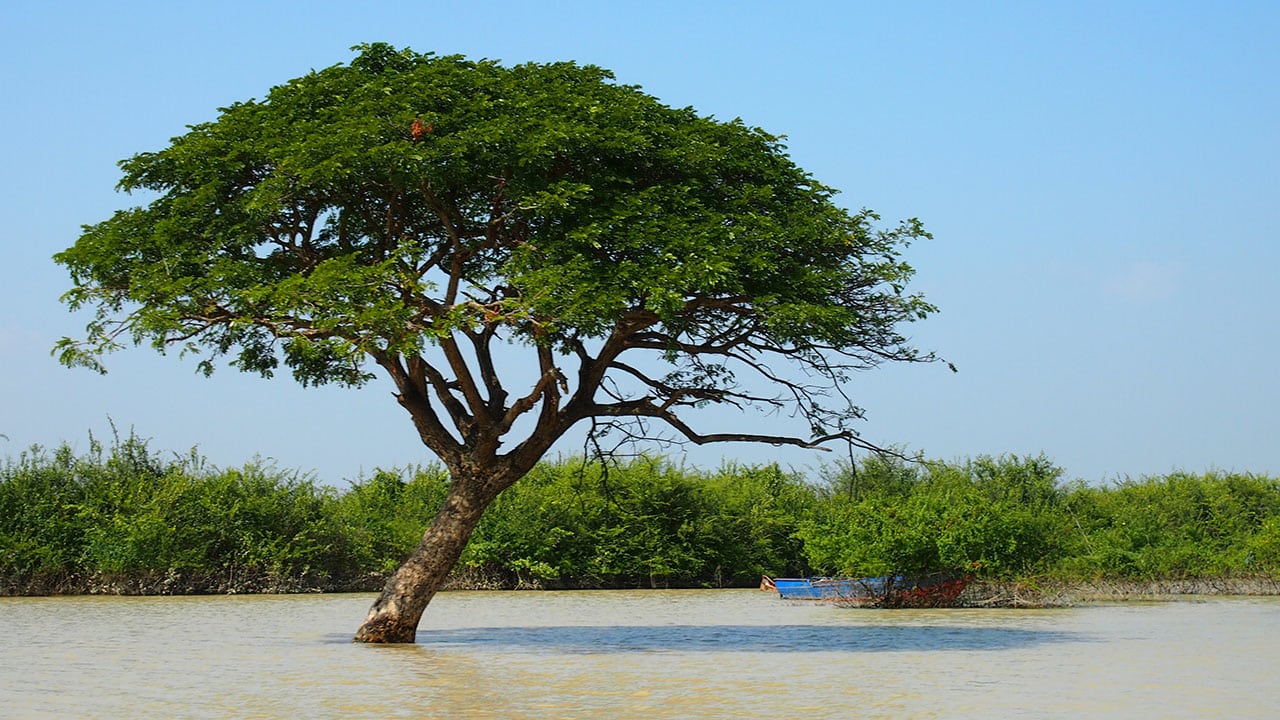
left=58, top=37, right=932, bottom=366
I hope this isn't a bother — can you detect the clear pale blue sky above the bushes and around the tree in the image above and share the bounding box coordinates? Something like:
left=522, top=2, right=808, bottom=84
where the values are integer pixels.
left=0, top=0, right=1280, bottom=483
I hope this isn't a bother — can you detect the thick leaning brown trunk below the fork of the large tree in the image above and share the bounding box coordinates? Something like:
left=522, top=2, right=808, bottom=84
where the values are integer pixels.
left=355, top=477, right=497, bottom=643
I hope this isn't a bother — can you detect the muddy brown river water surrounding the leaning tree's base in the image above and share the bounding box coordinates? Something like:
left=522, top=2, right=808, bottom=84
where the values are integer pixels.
left=0, top=591, right=1280, bottom=720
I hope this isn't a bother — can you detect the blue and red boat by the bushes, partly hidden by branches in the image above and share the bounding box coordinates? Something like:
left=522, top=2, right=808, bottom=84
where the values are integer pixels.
left=760, top=573, right=969, bottom=607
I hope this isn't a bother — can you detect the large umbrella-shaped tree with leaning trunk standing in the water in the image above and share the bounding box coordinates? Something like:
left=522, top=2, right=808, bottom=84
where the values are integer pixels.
left=55, top=44, right=934, bottom=642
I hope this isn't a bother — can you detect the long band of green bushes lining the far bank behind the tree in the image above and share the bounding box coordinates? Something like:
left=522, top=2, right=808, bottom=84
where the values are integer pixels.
left=0, top=436, right=1280, bottom=594
